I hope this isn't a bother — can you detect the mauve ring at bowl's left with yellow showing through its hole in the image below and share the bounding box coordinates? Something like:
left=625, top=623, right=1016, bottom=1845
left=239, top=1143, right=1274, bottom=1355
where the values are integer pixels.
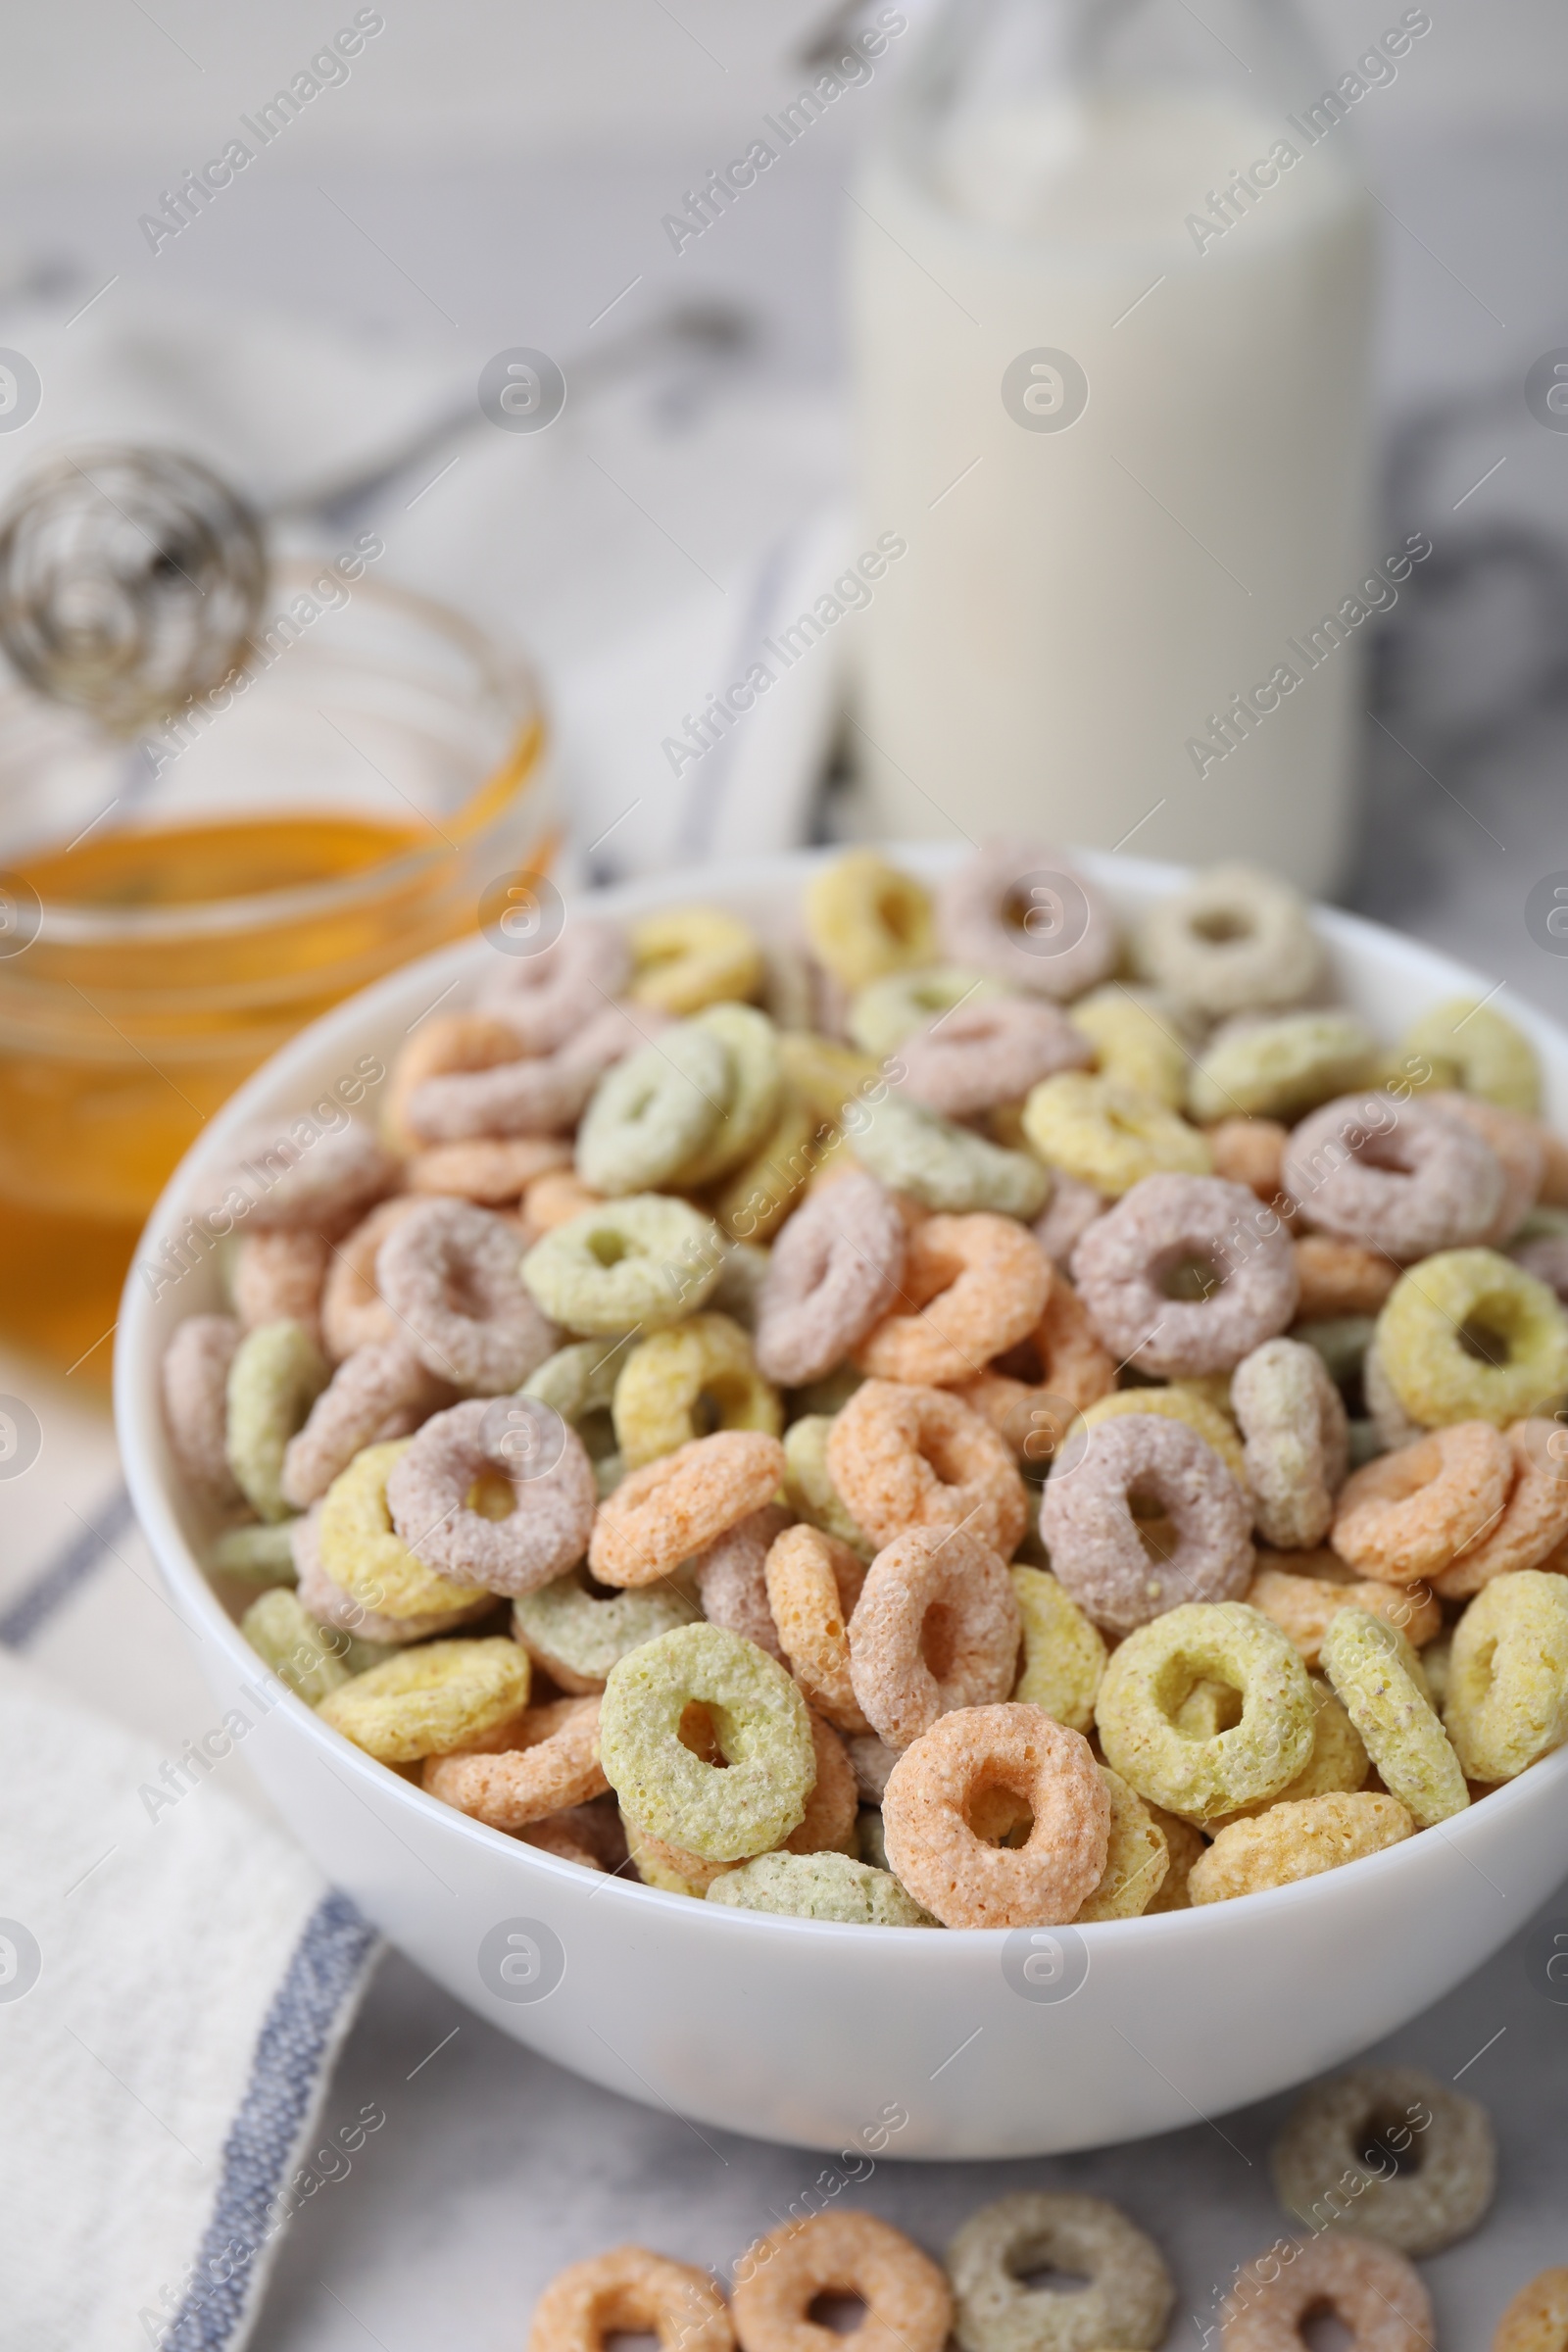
left=385, top=1397, right=597, bottom=1597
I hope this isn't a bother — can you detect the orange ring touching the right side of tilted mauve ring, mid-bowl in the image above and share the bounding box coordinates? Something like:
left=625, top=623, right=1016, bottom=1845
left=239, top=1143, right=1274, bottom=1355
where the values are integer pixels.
left=854, top=1209, right=1051, bottom=1388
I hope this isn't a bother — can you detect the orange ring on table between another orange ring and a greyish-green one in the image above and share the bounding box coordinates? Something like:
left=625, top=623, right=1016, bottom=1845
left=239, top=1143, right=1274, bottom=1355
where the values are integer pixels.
left=733, top=2213, right=953, bottom=2352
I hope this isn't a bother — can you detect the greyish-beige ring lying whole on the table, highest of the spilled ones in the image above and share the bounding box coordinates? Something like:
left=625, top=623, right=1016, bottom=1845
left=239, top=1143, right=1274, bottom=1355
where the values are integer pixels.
left=1269, top=2065, right=1497, bottom=2256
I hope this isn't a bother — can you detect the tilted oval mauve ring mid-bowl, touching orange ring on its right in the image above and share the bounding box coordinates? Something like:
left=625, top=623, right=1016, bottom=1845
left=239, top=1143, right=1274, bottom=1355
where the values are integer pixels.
left=757, top=1169, right=906, bottom=1388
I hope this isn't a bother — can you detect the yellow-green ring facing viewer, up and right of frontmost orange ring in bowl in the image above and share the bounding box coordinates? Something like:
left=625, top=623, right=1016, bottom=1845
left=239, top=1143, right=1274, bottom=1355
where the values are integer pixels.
left=1096, top=1601, right=1316, bottom=1821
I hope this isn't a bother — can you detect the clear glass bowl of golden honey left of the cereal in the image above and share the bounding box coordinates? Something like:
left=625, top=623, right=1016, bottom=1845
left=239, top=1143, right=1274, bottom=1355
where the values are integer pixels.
left=0, top=563, right=558, bottom=1386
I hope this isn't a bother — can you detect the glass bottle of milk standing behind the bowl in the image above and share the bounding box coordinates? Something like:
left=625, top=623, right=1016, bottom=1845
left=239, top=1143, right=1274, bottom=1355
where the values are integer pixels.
left=849, top=0, right=1382, bottom=889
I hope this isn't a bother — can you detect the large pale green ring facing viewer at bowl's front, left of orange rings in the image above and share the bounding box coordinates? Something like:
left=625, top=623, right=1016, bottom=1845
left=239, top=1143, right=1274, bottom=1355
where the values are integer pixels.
left=600, top=1625, right=815, bottom=1863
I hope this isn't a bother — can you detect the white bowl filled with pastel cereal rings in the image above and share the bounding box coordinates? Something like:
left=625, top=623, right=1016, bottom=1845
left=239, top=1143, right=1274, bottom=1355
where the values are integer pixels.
left=116, top=842, right=1568, bottom=2157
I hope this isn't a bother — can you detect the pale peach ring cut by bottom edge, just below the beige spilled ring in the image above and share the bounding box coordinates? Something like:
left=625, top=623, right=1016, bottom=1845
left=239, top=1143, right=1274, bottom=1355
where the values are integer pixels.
left=1220, top=2230, right=1437, bottom=2352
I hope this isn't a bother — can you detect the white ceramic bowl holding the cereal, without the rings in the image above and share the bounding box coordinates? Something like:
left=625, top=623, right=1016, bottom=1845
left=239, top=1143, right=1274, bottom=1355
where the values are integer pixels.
left=116, top=849, right=1568, bottom=2157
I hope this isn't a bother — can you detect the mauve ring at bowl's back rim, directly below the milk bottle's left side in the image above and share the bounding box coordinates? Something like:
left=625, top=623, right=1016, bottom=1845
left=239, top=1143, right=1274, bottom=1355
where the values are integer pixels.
left=938, top=837, right=1121, bottom=1002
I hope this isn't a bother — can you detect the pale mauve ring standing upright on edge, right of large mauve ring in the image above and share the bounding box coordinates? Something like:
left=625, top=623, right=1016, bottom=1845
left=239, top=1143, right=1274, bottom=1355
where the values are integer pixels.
left=1230, top=1339, right=1353, bottom=1552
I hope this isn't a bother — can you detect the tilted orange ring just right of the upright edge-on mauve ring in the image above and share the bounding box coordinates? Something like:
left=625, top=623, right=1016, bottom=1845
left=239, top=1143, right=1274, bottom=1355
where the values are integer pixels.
left=1328, top=1421, right=1514, bottom=1586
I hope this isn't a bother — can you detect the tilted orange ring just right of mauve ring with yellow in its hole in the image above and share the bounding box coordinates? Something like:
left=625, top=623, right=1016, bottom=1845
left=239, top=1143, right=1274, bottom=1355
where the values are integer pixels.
left=588, top=1430, right=785, bottom=1588
